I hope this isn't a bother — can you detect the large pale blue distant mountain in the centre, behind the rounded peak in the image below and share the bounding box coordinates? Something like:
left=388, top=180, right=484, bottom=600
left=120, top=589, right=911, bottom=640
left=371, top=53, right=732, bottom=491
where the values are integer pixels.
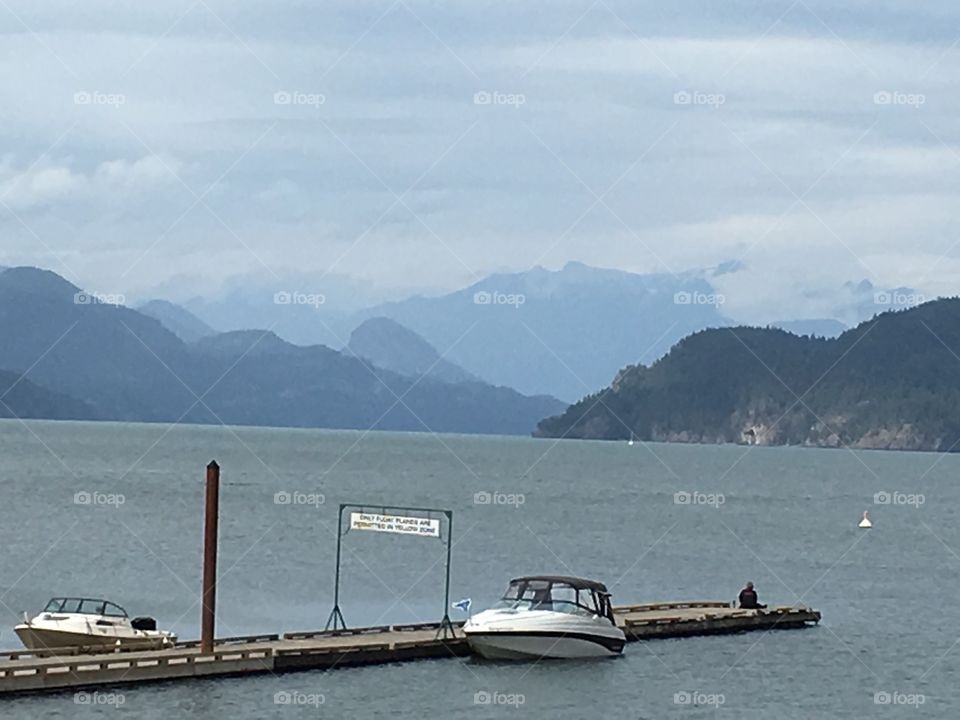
left=359, top=262, right=736, bottom=400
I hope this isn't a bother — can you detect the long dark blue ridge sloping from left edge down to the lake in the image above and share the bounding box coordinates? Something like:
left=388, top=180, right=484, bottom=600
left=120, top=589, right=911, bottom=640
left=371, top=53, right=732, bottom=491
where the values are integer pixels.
left=0, top=268, right=562, bottom=434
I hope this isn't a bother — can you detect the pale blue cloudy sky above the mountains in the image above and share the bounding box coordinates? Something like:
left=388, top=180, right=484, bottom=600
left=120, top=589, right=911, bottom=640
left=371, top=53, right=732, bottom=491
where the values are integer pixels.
left=0, top=0, right=960, bottom=321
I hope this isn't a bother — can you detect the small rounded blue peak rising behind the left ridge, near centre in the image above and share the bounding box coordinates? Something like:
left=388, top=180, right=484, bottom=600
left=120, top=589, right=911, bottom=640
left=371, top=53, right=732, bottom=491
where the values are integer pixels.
left=346, top=317, right=478, bottom=383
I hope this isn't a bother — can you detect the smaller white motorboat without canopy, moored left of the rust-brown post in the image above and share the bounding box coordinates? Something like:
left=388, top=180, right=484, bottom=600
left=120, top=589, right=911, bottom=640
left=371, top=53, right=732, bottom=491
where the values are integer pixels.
left=14, top=598, right=177, bottom=650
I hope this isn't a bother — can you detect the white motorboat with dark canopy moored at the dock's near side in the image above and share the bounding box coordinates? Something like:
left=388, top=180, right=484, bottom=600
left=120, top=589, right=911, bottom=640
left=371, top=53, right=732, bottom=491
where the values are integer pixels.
left=463, top=575, right=626, bottom=660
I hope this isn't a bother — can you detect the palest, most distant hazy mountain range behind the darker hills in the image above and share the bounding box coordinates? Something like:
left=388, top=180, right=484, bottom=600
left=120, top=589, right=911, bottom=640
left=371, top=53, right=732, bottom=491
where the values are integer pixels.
left=163, top=261, right=915, bottom=402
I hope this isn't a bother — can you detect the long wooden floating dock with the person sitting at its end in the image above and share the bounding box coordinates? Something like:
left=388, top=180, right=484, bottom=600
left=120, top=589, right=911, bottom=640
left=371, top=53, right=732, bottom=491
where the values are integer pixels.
left=0, top=602, right=820, bottom=696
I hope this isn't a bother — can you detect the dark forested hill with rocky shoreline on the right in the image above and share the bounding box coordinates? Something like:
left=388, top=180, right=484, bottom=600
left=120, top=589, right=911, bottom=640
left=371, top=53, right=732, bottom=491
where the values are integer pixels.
left=536, top=299, right=960, bottom=451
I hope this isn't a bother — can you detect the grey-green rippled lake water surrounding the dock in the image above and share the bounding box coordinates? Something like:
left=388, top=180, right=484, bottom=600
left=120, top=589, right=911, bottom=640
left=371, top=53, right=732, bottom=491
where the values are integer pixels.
left=0, top=421, right=960, bottom=720
